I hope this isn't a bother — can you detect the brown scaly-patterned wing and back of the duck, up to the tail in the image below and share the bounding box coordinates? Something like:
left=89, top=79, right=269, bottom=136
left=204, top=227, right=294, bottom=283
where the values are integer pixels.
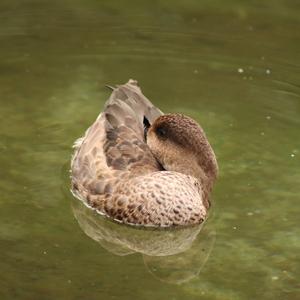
left=71, top=80, right=162, bottom=198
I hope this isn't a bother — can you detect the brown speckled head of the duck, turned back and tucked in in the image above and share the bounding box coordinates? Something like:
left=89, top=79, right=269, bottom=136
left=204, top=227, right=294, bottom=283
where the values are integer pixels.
left=146, top=114, right=218, bottom=188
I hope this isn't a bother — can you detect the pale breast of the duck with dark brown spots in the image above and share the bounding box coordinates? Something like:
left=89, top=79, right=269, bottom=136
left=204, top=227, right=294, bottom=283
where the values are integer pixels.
left=102, top=171, right=207, bottom=226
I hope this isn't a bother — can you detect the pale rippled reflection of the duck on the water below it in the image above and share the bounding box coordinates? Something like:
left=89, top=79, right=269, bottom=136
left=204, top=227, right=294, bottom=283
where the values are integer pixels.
left=72, top=199, right=216, bottom=283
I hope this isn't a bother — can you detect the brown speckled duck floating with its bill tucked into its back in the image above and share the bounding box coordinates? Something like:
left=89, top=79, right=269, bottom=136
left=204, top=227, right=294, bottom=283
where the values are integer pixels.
left=70, top=79, right=218, bottom=227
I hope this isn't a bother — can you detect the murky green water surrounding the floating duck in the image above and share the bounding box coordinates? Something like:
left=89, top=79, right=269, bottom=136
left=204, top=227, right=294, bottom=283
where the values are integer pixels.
left=0, top=0, right=300, bottom=300
